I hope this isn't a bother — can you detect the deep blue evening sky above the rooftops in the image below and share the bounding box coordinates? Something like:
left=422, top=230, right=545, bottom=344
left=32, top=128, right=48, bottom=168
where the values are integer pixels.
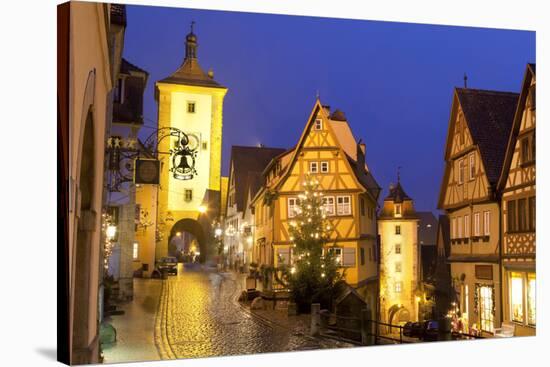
left=124, top=6, right=535, bottom=212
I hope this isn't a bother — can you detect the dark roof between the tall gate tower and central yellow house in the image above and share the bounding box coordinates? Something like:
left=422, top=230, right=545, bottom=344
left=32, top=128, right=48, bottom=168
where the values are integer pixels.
left=231, top=146, right=285, bottom=212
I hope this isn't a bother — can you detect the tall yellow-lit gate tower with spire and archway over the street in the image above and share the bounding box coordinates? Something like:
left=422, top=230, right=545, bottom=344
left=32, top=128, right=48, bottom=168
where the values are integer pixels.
left=155, top=22, right=227, bottom=259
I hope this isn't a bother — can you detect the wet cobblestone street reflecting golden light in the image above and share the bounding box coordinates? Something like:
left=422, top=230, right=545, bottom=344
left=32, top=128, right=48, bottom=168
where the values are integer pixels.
left=155, top=269, right=354, bottom=359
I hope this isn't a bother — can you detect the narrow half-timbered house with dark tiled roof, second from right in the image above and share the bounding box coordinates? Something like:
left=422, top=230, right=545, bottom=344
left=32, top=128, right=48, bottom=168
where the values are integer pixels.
left=438, top=88, right=518, bottom=335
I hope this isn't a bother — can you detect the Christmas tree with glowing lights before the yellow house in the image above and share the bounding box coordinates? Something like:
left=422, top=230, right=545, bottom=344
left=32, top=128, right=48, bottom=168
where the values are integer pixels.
left=283, top=177, right=343, bottom=312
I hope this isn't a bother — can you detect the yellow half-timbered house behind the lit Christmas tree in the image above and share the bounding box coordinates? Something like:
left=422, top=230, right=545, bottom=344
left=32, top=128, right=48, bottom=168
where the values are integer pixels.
left=251, top=100, right=380, bottom=294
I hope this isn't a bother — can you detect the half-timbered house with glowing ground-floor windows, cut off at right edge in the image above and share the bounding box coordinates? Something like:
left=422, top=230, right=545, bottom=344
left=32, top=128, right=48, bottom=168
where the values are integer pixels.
left=499, top=64, right=537, bottom=335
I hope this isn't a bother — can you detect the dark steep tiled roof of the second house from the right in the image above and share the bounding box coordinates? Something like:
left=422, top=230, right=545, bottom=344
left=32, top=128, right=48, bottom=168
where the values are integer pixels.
left=456, top=88, right=519, bottom=184
